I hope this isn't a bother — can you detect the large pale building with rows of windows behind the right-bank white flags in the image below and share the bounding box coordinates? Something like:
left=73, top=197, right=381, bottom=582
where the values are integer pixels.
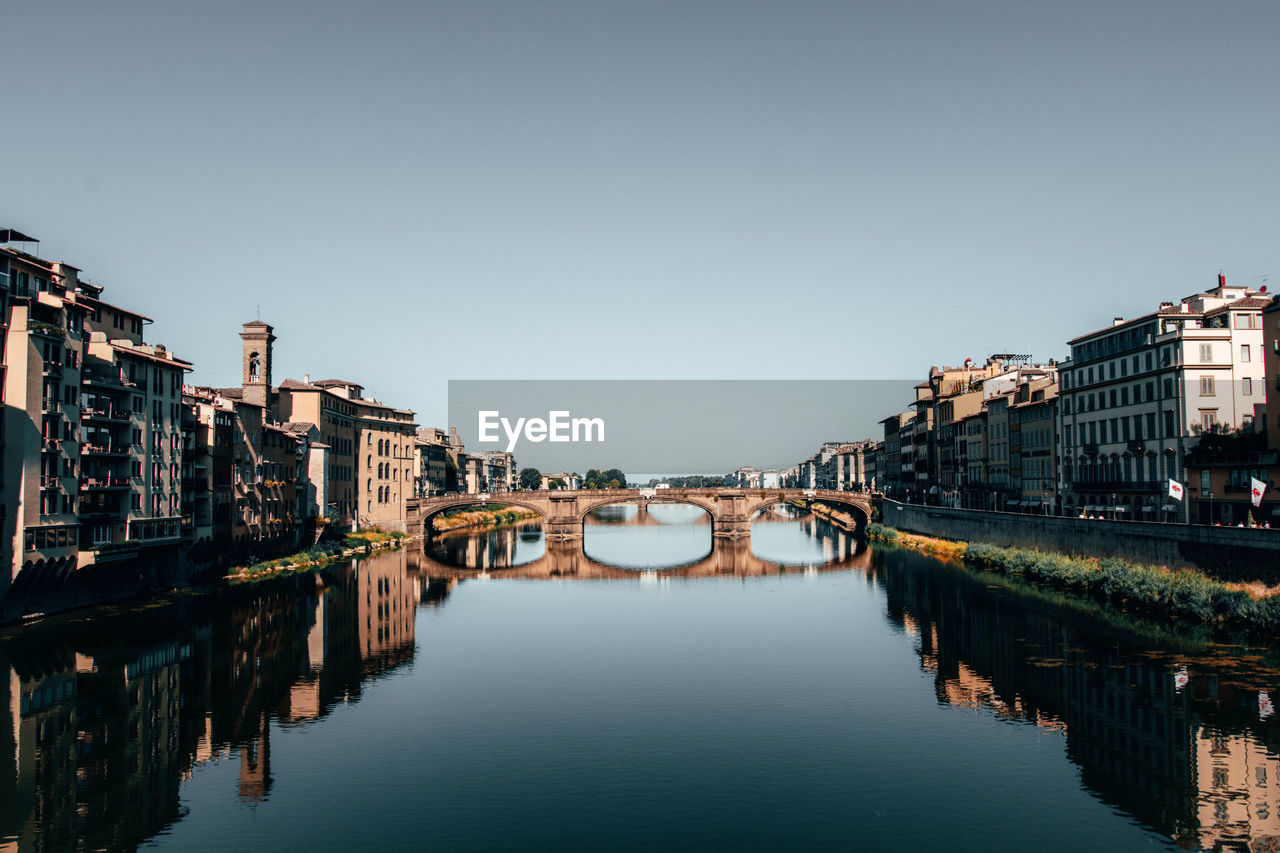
left=1057, top=275, right=1267, bottom=520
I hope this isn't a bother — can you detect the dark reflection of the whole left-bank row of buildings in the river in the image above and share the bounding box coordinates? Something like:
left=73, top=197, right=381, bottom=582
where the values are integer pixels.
left=0, top=552, right=422, bottom=850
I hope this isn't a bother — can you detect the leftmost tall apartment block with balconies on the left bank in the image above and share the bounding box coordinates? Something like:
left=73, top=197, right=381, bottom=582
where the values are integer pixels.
left=0, top=232, right=191, bottom=593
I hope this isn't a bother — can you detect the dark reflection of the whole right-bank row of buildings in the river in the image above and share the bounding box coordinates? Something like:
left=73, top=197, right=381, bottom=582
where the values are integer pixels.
left=877, top=552, right=1280, bottom=849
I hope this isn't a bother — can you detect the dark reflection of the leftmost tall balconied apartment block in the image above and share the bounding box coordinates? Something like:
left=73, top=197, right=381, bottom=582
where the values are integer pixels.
left=0, top=640, right=191, bottom=850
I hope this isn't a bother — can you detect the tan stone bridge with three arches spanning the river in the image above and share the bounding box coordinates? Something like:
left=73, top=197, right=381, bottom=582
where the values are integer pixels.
left=406, top=488, right=872, bottom=542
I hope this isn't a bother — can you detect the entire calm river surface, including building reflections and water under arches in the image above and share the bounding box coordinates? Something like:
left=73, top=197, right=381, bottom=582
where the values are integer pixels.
left=0, top=505, right=1280, bottom=850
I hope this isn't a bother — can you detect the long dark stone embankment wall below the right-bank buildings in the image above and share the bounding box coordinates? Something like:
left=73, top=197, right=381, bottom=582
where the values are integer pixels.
left=882, top=498, right=1280, bottom=584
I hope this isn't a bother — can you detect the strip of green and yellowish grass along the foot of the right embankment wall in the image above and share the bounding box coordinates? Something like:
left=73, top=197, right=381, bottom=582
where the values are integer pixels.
left=867, top=524, right=1280, bottom=634
